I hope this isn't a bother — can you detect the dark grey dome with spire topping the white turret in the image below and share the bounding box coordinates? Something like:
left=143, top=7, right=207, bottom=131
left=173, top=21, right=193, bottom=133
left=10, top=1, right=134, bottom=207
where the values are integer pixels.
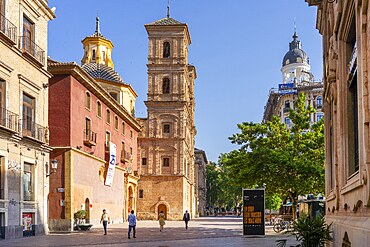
left=283, top=32, right=309, bottom=67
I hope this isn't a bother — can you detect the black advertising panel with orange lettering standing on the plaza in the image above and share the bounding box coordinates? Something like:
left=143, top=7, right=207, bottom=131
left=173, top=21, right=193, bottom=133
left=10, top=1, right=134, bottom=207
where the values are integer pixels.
left=243, top=189, right=265, bottom=235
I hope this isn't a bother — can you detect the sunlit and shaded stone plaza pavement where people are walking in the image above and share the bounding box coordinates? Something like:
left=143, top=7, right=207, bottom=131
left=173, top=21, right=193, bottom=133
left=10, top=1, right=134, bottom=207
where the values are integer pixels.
left=0, top=216, right=298, bottom=247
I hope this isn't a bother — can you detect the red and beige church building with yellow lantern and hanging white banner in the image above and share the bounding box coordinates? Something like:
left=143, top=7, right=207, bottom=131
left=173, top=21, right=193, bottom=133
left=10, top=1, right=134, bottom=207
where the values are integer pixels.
left=48, top=17, right=140, bottom=231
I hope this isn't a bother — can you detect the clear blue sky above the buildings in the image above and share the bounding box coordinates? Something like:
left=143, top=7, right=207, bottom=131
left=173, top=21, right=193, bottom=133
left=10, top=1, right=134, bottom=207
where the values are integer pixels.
left=48, top=0, right=322, bottom=162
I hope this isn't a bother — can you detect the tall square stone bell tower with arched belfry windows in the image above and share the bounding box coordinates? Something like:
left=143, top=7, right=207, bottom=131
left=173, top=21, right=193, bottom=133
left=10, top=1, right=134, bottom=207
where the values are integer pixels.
left=137, top=14, right=196, bottom=219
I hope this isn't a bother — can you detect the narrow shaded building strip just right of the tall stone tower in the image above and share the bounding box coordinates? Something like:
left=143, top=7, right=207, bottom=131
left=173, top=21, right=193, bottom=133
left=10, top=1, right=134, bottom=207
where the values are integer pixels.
left=194, top=148, right=208, bottom=216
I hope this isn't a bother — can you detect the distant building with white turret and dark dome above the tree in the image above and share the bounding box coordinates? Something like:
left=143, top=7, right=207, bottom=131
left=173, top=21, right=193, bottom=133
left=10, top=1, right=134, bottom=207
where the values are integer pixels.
left=263, top=32, right=324, bottom=127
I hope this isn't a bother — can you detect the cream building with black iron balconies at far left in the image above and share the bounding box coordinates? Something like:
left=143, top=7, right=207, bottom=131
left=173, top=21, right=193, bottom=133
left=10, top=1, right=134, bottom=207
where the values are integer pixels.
left=0, top=0, right=55, bottom=239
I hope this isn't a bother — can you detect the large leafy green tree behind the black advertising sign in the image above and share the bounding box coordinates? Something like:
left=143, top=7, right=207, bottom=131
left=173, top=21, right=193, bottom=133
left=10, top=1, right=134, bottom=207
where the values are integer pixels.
left=222, top=94, right=325, bottom=217
